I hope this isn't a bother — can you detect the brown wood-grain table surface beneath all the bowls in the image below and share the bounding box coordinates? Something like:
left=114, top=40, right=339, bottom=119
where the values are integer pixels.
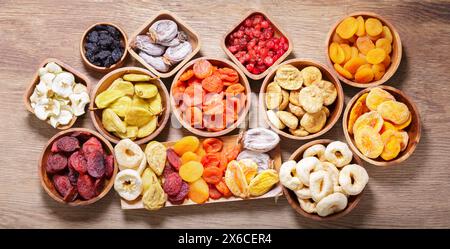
left=0, top=0, right=450, bottom=228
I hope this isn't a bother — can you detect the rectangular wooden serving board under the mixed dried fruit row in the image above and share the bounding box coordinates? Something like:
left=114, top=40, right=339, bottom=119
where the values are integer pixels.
left=120, top=135, right=282, bottom=209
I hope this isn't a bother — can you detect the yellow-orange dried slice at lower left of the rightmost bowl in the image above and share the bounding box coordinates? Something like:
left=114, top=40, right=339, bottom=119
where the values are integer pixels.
left=355, top=125, right=384, bottom=158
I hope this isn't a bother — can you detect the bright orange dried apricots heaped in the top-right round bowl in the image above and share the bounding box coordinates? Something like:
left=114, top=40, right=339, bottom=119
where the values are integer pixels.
left=328, top=16, right=393, bottom=83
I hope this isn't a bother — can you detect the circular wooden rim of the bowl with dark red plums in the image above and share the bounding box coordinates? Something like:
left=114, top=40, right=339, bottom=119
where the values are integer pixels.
left=38, top=127, right=119, bottom=207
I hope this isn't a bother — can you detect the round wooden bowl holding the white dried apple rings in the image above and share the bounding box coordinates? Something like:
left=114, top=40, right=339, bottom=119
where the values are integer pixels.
left=282, top=139, right=364, bottom=221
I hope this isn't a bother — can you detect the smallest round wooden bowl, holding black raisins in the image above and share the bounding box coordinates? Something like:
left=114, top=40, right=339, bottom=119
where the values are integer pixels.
left=80, top=22, right=128, bottom=73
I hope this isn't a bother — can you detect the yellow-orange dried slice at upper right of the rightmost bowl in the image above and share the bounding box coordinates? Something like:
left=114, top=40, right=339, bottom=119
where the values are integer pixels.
left=377, top=100, right=411, bottom=125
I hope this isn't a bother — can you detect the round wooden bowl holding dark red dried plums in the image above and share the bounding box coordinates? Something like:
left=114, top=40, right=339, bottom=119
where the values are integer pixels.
left=38, top=128, right=119, bottom=206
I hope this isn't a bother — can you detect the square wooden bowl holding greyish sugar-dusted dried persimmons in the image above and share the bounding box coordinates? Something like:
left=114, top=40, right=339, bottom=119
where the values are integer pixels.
left=127, top=10, right=201, bottom=78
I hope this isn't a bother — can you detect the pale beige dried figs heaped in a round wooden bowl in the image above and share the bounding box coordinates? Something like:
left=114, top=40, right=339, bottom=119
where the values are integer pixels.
left=264, top=64, right=337, bottom=137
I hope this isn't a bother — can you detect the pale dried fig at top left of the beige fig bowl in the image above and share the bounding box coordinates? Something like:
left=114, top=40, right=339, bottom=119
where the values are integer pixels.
left=274, top=64, right=303, bottom=90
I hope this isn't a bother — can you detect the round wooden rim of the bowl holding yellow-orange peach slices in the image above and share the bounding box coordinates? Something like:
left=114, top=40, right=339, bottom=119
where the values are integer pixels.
left=342, top=85, right=422, bottom=167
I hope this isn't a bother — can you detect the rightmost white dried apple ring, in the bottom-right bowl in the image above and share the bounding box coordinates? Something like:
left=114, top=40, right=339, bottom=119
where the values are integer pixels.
left=339, top=164, right=369, bottom=195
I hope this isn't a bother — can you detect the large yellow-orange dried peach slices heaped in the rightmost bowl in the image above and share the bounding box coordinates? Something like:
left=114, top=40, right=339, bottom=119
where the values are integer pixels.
left=347, top=87, right=412, bottom=161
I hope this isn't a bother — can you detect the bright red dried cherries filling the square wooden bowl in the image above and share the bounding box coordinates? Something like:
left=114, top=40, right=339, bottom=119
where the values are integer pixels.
left=225, top=14, right=289, bottom=74
